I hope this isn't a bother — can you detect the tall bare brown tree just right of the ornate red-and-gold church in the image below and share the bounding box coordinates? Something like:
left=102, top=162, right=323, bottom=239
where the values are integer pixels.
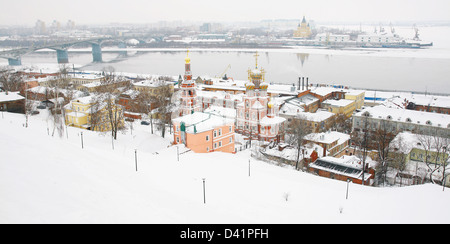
left=286, top=116, right=311, bottom=170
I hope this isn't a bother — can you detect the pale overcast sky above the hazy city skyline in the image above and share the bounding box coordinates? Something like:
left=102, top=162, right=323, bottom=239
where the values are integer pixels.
left=0, top=0, right=450, bottom=26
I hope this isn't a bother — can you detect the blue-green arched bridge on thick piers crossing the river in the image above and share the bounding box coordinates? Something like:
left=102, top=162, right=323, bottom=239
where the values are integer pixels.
left=0, top=37, right=121, bottom=66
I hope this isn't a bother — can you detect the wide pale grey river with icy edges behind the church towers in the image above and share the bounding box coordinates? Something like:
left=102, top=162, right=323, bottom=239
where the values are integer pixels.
left=6, top=26, right=450, bottom=94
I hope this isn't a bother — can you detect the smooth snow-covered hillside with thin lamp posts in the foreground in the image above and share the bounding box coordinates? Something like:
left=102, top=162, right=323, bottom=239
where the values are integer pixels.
left=0, top=110, right=450, bottom=223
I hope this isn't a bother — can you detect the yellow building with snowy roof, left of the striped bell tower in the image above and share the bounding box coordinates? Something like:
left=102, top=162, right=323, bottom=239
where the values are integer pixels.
left=65, top=96, right=124, bottom=131
